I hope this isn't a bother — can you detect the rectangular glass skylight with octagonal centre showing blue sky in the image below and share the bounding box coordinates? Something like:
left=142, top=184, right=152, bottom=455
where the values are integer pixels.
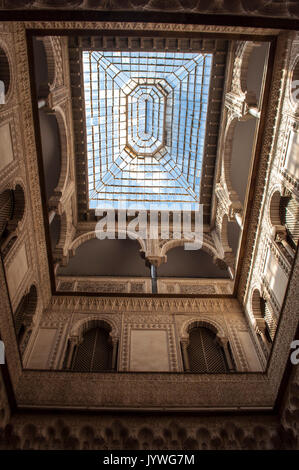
left=83, top=51, right=212, bottom=210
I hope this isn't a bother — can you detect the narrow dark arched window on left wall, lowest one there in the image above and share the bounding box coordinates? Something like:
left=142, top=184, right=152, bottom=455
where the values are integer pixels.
left=14, top=285, right=37, bottom=350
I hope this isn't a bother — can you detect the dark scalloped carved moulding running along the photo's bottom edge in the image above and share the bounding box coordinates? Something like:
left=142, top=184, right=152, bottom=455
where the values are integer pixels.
left=0, top=362, right=299, bottom=450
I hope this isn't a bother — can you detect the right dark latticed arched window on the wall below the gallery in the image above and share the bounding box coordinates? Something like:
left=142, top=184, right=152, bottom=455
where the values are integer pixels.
left=187, top=326, right=228, bottom=374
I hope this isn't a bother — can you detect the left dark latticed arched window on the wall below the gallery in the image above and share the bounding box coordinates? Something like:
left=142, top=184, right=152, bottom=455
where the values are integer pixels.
left=71, top=326, right=113, bottom=372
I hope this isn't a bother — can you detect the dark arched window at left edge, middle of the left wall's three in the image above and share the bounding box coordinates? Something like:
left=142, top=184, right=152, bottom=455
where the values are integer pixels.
left=0, top=185, right=25, bottom=257
